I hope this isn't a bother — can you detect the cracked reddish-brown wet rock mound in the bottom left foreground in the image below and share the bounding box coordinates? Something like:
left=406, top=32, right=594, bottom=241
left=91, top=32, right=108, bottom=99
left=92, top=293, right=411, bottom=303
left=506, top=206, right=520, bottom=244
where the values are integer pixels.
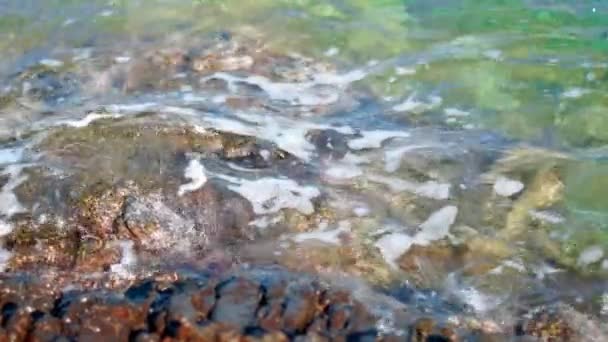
left=0, top=267, right=428, bottom=341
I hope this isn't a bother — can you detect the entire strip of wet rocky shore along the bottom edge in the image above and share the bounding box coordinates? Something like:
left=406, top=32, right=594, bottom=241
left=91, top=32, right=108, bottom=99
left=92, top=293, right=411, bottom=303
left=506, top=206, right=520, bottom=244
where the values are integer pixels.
left=0, top=266, right=580, bottom=342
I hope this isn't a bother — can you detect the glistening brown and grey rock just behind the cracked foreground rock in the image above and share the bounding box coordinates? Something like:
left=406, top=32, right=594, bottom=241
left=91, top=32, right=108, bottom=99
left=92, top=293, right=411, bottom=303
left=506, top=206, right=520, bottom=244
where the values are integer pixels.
left=6, top=178, right=254, bottom=273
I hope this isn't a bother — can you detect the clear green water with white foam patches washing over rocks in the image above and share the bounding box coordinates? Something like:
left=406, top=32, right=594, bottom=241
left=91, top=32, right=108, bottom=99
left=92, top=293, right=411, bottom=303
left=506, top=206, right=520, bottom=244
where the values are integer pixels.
left=0, top=0, right=608, bottom=336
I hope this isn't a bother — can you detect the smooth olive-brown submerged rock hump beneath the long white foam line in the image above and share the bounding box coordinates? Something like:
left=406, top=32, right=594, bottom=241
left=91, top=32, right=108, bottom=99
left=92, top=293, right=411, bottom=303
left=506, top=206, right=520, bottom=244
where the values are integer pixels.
left=36, top=119, right=304, bottom=191
